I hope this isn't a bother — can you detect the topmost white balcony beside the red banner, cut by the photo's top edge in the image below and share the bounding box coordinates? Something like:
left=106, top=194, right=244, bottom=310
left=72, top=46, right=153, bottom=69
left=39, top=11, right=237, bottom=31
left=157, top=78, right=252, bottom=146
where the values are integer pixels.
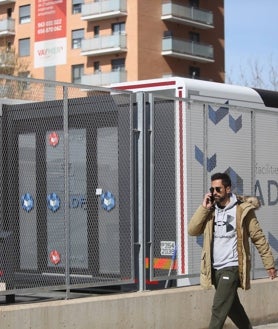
left=81, top=0, right=127, bottom=21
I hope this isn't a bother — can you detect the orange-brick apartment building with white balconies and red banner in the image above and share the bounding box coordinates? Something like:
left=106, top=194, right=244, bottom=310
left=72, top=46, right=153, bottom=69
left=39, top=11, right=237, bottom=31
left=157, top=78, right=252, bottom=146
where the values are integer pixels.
left=0, top=0, right=225, bottom=86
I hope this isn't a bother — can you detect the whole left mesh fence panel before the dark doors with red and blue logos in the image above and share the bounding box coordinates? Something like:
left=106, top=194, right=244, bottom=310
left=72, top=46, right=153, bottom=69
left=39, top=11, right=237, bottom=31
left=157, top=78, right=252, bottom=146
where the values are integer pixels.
left=0, top=77, right=134, bottom=294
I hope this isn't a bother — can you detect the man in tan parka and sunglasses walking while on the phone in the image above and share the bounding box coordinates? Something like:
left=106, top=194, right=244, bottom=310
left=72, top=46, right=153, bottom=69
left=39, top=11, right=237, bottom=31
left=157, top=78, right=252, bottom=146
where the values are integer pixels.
left=188, top=173, right=276, bottom=329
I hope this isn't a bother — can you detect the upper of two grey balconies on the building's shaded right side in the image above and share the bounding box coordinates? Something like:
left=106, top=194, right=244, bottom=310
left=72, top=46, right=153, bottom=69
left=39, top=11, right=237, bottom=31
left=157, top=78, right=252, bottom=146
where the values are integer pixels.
left=161, top=1, right=214, bottom=29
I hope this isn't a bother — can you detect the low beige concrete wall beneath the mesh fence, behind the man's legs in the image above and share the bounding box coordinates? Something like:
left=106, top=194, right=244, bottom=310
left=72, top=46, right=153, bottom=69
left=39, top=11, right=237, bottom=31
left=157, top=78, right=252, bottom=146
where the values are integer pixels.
left=0, top=279, right=278, bottom=329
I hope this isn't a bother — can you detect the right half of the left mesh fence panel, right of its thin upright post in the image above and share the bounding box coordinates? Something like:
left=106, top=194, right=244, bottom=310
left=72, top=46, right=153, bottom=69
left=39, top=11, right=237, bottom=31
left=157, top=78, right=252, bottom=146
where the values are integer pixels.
left=65, top=95, right=134, bottom=285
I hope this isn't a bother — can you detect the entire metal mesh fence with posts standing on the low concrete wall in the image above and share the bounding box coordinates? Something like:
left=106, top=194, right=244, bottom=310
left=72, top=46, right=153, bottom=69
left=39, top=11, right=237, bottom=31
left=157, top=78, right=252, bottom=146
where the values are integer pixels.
left=0, top=76, right=278, bottom=295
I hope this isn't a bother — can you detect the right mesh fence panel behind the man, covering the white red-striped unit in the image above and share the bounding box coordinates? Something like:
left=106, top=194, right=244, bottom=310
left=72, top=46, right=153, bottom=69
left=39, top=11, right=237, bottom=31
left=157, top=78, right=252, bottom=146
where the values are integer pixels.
left=147, top=94, right=278, bottom=285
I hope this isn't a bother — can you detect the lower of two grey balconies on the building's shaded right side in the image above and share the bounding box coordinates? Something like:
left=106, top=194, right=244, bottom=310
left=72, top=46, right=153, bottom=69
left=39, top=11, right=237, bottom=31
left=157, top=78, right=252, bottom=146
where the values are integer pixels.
left=161, top=37, right=214, bottom=63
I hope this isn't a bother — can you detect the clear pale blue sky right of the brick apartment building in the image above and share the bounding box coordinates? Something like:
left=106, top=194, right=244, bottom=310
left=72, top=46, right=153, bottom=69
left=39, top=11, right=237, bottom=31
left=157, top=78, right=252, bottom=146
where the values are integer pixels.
left=224, top=0, right=278, bottom=87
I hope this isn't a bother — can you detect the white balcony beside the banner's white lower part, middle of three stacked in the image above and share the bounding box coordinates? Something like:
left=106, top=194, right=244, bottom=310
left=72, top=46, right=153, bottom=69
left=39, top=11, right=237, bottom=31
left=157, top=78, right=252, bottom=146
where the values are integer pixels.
left=81, top=34, right=127, bottom=56
